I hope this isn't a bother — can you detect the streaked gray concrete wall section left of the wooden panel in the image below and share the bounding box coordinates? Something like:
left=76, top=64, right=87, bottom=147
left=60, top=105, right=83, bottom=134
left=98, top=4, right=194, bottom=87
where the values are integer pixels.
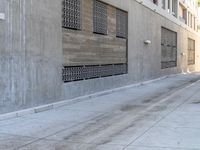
left=0, top=0, right=62, bottom=113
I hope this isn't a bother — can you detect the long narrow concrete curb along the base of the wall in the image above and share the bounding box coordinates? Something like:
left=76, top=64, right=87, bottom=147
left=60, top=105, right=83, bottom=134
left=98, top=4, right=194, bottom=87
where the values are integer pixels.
left=0, top=74, right=180, bottom=121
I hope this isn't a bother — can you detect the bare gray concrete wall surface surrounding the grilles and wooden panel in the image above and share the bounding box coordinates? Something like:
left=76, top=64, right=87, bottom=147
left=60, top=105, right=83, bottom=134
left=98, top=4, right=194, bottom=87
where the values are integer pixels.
left=0, top=0, right=200, bottom=114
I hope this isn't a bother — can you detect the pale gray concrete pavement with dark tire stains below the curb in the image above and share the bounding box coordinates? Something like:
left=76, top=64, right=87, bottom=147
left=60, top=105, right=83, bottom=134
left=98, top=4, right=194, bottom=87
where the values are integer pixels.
left=0, top=73, right=200, bottom=150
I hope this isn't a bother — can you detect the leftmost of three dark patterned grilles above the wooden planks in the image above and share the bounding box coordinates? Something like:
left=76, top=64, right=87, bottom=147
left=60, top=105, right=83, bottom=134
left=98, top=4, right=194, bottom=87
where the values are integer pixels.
left=62, top=0, right=81, bottom=30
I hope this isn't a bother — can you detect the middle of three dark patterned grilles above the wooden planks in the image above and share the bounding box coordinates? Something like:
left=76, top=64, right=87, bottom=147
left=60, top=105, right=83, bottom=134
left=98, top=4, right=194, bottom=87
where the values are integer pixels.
left=94, top=0, right=107, bottom=34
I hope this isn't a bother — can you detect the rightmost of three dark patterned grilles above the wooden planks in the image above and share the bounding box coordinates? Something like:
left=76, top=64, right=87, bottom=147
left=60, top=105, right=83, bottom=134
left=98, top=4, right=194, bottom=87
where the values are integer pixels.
left=116, top=9, right=128, bottom=38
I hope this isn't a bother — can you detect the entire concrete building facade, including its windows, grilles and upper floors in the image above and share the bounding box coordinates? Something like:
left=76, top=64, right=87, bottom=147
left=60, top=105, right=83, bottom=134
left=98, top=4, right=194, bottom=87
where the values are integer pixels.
left=0, top=0, right=200, bottom=114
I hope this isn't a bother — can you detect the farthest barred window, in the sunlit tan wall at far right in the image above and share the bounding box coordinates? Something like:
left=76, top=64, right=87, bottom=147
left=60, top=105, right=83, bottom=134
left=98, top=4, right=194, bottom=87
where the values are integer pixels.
left=188, top=39, right=195, bottom=65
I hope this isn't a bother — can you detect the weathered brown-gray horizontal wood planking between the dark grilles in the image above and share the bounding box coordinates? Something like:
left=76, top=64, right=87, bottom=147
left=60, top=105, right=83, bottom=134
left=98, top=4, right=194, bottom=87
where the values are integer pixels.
left=63, top=0, right=127, bottom=66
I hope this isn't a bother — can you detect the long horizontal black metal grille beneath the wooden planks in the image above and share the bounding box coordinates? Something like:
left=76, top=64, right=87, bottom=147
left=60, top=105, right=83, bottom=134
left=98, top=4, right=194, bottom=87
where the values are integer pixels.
left=62, top=64, right=127, bottom=82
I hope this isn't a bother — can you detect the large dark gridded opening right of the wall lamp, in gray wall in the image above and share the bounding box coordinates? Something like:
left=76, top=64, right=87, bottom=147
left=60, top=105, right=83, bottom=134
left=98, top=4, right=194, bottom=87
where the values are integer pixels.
left=161, top=27, right=177, bottom=69
